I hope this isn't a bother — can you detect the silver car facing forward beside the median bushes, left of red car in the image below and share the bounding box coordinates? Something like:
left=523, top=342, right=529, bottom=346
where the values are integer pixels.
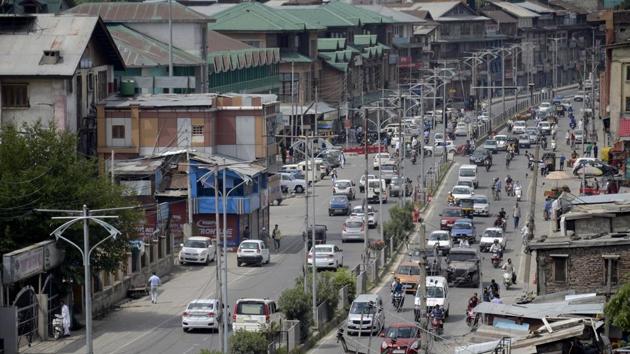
left=346, top=294, right=385, bottom=335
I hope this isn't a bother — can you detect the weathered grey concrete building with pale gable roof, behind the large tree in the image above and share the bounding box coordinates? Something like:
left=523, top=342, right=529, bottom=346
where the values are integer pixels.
left=0, top=15, right=125, bottom=155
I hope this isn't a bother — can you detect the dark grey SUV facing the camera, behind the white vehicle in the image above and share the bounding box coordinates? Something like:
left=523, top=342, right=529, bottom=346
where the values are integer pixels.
left=446, top=247, right=481, bottom=288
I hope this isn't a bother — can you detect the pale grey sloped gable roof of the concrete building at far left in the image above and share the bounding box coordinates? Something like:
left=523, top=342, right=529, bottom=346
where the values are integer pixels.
left=0, top=14, right=125, bottom=76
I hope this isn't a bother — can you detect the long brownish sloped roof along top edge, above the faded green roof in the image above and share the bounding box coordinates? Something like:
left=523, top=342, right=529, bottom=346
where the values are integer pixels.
left=66, top=1, right=212, bottom=23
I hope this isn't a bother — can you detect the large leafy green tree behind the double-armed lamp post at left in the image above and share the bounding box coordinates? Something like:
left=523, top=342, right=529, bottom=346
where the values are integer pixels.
left=0, top=124, right=140, bottom=283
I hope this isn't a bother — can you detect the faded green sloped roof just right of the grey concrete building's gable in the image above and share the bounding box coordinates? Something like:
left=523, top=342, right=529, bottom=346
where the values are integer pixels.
left=107, top=24, right=203, bottom=68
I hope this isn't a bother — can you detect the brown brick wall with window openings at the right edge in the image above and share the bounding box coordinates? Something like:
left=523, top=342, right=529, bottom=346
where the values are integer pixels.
left=536, top=245, right=630, bottom=295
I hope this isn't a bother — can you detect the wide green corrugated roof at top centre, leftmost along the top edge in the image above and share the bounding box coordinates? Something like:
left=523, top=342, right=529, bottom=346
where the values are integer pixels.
left=208, top=2, right=325, bottom=32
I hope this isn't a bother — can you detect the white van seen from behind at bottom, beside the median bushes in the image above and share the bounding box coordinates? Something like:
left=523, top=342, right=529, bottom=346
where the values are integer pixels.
left=232, top=298, right=282, bottom=332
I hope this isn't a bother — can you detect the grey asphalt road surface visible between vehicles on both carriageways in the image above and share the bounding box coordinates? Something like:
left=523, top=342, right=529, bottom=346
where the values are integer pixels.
left=29, top=88, right=572, bottom=354
